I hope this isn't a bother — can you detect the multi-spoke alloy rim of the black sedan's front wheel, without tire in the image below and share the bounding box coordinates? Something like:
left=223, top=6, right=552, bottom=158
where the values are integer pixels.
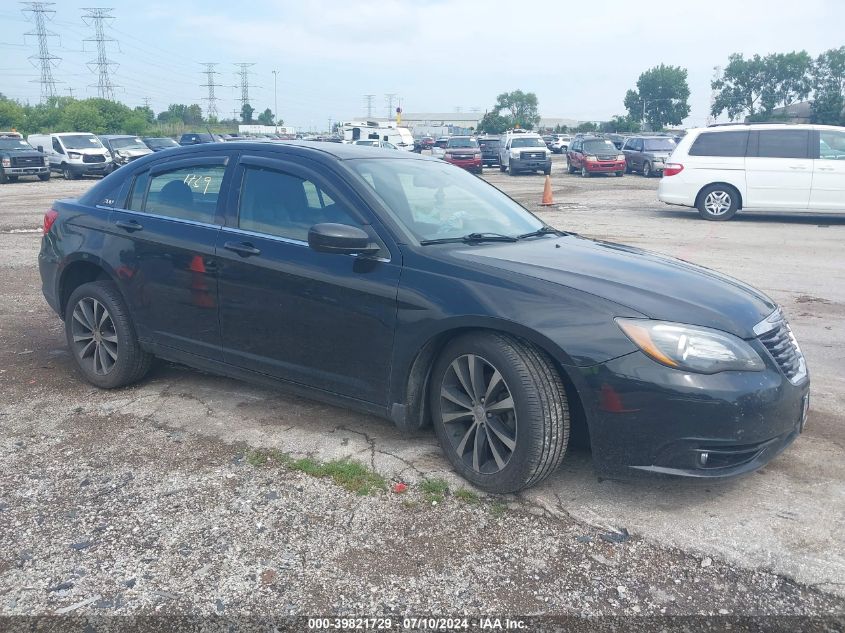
left=440, top=354, right=517, bottom=475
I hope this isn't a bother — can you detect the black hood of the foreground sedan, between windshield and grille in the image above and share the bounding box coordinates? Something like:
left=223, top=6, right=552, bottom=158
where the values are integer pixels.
left=455, top=236, right=776, bottom=339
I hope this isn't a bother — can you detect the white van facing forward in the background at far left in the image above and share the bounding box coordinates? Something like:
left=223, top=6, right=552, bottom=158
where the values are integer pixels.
left=26, top=132, right=112, bottom=180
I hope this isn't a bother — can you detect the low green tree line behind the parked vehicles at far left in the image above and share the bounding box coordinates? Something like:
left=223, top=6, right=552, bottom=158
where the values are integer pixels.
left=0, top=93, right=283, bottom=135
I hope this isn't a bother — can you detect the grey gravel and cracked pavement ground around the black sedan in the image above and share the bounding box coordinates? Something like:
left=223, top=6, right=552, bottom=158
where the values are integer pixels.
left=0, top=157, right=845, bottom=617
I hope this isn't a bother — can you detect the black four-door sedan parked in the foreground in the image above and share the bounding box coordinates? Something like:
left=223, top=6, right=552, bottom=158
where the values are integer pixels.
left=38, top=142, right=809, bottom=492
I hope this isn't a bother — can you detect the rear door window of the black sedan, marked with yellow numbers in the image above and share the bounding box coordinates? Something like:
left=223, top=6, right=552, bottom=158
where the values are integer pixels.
left=144, top=165, right=226, bottom=224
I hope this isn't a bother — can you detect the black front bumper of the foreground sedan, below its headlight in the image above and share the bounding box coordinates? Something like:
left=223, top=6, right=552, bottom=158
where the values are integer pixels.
left=579, top=341, right=810, bottom=477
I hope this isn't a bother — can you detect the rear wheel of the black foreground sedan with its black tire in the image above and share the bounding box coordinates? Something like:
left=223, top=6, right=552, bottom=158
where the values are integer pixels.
left=65, top=281, right=153, bottom=389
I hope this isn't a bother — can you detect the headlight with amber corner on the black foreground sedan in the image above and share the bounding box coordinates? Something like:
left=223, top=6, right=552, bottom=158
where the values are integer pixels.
left=616, top=318, right=765, bottom=374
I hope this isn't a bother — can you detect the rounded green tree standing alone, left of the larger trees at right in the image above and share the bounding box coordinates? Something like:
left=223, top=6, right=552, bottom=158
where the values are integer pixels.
left=624, top=64, right=690, bottom=130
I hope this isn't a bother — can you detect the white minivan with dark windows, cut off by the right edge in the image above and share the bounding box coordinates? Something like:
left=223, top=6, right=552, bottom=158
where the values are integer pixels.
left=657, top=123, right=845, bottom=220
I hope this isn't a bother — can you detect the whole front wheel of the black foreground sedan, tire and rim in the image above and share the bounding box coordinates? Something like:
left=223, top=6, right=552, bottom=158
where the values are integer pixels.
left=429, top=333, right=569, bottom=493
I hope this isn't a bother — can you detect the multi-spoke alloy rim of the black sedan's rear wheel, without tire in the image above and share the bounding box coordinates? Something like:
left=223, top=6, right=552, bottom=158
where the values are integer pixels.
left=71, top=297, right=118, bottom=376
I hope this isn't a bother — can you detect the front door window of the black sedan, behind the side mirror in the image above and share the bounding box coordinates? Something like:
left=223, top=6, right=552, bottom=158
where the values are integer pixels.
left=238, top=167, right=360, bottom=242
